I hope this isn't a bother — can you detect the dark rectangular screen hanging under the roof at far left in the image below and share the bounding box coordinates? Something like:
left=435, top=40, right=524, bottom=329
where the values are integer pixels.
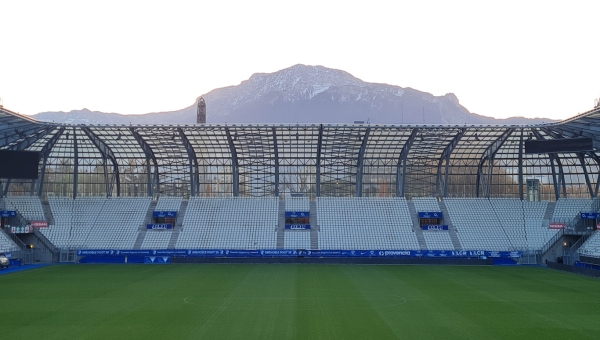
left=0, top=150, right=40, bottom=179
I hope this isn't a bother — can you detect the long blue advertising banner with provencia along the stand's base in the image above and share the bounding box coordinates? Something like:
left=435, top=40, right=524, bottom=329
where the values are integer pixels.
left=77, top=249, right=522, bottom=258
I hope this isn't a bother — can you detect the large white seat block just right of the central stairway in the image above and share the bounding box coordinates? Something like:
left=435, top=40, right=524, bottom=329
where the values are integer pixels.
left=317, top=197, right=420, bottom=250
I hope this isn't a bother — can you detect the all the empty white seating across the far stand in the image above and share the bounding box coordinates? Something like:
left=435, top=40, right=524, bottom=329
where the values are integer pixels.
left=4, top=196, right=591, bottom=250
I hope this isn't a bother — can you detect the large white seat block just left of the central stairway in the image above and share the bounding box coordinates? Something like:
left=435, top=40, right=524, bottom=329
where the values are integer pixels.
left=175, top=197, right=279, bottom=249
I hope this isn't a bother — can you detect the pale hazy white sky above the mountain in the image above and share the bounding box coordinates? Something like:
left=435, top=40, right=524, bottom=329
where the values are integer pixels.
left=0, top=0, right=600, bottom=119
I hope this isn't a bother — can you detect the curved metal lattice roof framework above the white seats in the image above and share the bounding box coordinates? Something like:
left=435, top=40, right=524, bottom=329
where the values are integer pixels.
left=0, top=104, right=600, bottom=200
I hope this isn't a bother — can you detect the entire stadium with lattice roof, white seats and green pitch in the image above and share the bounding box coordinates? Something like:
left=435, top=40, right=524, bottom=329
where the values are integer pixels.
left=0, top=107, right=600, bottom=339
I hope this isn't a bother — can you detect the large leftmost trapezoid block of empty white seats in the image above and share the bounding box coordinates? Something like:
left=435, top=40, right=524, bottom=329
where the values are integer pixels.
left=40, top=197, right=151, bottom=249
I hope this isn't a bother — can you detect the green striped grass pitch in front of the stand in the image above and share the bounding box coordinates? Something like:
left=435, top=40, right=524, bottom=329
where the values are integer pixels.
left=0, top=264, right=600, bottom=340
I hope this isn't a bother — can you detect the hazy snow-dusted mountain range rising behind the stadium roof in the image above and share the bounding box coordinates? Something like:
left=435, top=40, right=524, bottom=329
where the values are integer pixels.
left=33, top=65, right=552, bottom=124
